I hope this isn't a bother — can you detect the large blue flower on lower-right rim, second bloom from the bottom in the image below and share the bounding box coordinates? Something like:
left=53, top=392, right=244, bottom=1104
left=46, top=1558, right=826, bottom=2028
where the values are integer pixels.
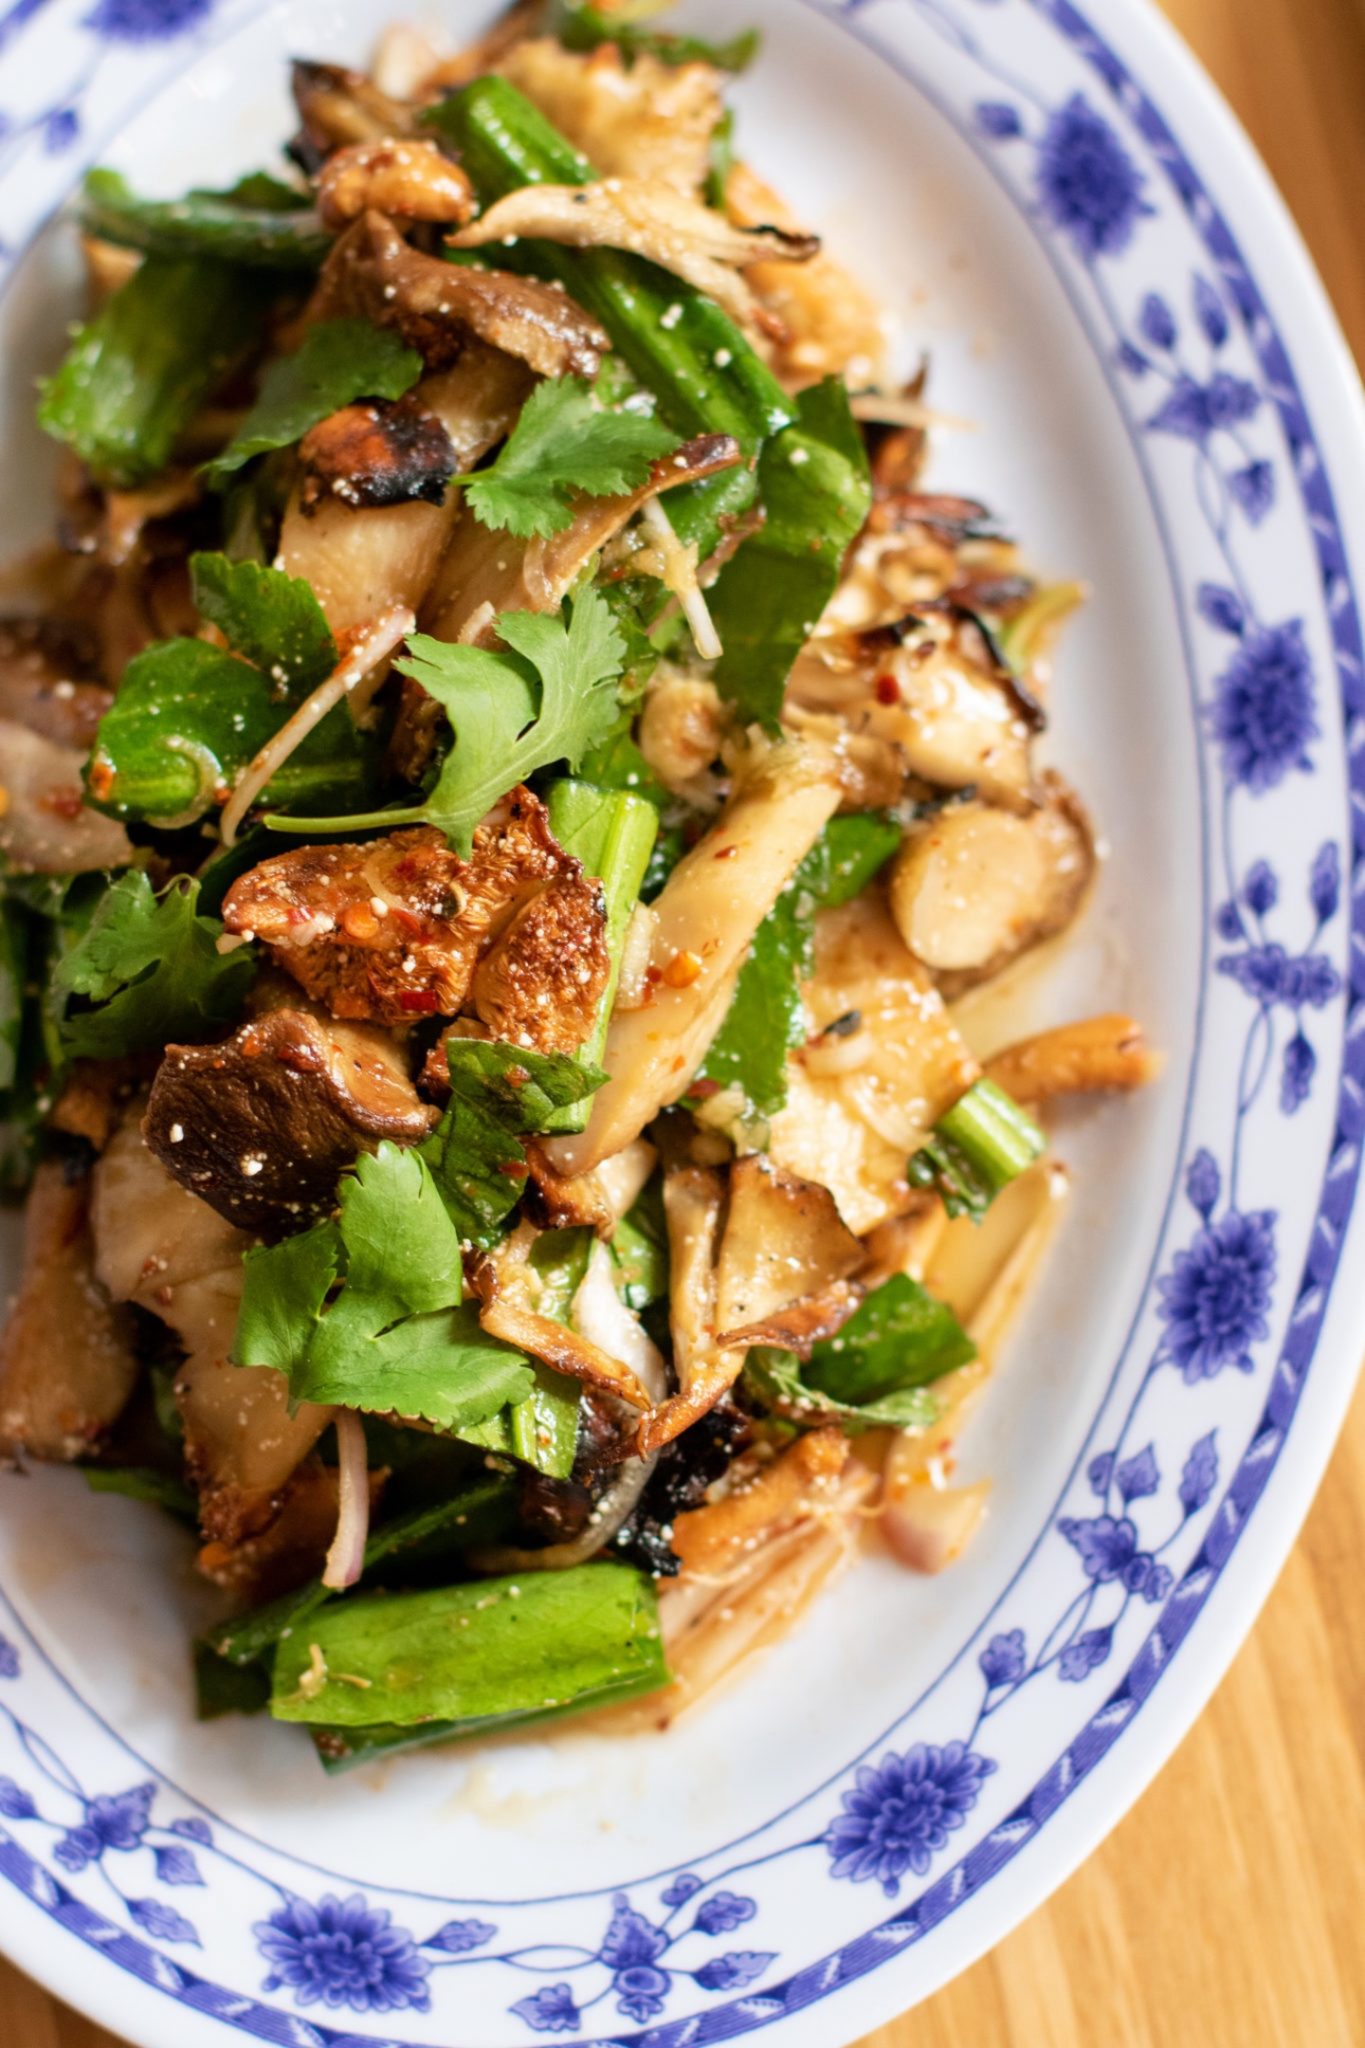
left=825, top=1743, right=995, bottom=1898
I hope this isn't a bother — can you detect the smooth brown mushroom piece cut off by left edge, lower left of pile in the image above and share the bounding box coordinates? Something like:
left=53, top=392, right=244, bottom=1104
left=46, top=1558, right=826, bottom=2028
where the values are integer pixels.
left=0, top=1159, right=137, bottom=1462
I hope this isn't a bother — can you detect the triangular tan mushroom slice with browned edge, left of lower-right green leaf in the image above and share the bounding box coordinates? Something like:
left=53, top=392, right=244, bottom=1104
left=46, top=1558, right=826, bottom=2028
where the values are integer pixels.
left=716, top=1153, right=864, bottom=1350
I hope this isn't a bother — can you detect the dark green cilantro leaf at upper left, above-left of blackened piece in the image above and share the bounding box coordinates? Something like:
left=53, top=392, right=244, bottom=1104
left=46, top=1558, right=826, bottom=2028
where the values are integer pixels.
left=201, top=319, right=422, bottom=489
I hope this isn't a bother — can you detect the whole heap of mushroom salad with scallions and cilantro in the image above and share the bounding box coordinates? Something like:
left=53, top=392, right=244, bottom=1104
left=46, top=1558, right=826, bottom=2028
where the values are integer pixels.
left=0, top=0, right=1152, bottom=1769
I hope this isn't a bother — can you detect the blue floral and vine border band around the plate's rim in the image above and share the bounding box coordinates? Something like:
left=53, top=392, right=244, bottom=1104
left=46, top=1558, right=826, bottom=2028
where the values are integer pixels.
left=0, top=0, right=1365, bottom=2048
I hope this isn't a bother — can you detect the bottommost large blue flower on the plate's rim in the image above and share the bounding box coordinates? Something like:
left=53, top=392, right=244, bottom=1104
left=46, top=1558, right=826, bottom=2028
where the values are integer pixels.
left=252, top=1892, right=432, bottom=2013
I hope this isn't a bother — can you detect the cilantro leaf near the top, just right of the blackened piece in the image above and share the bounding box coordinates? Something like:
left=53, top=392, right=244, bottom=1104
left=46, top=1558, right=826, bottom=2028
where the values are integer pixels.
left=465, top=377, right=677, bottom=541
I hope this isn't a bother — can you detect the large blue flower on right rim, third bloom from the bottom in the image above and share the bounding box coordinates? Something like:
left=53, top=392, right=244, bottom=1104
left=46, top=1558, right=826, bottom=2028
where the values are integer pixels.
left=1156, top=1208, right=1275, bottom=1386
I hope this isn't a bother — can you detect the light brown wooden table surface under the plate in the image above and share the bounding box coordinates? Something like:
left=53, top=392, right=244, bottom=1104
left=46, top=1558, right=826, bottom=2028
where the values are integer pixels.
left=0, top=0, right=1365, bottom=2048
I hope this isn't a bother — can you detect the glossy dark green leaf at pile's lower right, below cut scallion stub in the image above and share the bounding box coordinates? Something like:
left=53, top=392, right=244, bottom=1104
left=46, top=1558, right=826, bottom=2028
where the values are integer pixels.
left=745, top=1274, right=976, bottom=1436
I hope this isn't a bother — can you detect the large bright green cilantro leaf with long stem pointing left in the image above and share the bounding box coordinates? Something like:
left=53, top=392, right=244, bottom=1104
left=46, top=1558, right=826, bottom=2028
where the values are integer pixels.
left=266, top=590, right=626, bottom=854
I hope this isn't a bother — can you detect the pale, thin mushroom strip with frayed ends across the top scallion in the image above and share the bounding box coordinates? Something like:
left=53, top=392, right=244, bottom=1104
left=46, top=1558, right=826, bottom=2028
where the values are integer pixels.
left=450, top=178, right=821, bottom=324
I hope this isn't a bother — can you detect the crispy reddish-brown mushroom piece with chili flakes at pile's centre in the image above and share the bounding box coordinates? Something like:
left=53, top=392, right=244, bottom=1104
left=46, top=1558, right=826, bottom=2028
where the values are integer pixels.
left=223, top=786, right=604, bottom=1024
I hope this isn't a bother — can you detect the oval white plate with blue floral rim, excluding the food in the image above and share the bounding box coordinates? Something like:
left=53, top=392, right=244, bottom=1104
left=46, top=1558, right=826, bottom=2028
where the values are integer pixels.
left=0, top=0, right=1365, bottom=2048
